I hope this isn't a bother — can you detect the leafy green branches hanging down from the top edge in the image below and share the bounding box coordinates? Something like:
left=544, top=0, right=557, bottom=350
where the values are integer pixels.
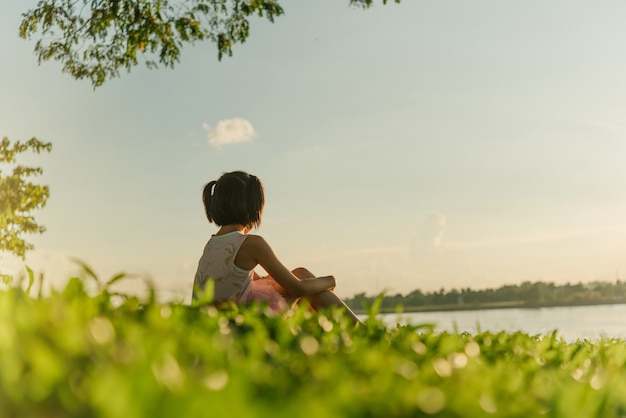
left=19, top=0, right=400, bottom=88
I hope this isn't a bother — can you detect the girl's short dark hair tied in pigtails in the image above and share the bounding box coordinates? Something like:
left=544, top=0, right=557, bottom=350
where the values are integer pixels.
left=202, top=171, right=265, bottom=228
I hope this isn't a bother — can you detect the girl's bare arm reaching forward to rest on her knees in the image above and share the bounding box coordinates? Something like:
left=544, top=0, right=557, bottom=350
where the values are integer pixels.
left=237, top=235, right=336, bottom=297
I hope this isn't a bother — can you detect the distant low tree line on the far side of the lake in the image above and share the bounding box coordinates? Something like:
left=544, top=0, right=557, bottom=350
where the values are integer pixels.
left=346, top=280, right=626, bottom=311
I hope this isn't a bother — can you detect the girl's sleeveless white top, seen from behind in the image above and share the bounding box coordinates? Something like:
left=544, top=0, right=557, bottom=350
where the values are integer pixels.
left=192, top=231, right=254, bottom=302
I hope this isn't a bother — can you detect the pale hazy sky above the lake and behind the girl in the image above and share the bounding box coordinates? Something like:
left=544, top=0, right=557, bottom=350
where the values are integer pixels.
left=0, top=0, right=626, bottom=296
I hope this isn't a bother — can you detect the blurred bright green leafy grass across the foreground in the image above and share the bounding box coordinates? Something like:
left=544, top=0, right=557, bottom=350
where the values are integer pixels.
left=0, top=271, right=626, bottom=418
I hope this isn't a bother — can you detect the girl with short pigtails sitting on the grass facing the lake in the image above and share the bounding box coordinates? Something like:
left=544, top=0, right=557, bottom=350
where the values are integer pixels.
left=193, top=171, right=360, bottom=323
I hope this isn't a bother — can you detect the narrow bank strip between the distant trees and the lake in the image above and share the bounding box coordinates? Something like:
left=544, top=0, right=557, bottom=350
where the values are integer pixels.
left=353, top=299, right=626, bottom=315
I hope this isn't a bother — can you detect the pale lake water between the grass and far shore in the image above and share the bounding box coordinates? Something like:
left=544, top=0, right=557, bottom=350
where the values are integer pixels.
left=370, top=304, right=626, bottom=342
